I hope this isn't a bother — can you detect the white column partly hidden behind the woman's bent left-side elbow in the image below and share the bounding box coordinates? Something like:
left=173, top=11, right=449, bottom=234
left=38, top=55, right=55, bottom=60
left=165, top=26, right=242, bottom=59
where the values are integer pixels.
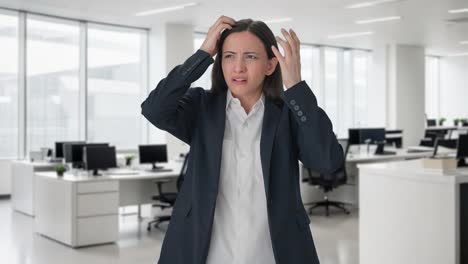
left=148, top=24, right=194, bottom=159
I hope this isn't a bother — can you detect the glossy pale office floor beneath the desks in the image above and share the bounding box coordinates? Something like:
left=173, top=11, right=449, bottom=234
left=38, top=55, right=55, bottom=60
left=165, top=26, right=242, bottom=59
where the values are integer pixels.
left=0, top=200, right=358, bottom=264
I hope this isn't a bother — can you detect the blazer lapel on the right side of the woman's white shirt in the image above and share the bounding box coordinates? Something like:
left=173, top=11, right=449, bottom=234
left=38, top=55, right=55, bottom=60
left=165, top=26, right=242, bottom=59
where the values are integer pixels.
left=260, top=98, right=281, bottom=198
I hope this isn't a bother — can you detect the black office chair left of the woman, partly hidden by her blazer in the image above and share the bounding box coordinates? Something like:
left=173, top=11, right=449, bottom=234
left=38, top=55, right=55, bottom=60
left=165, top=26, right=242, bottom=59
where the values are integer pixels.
left=147, top=153, right=189, bottom=231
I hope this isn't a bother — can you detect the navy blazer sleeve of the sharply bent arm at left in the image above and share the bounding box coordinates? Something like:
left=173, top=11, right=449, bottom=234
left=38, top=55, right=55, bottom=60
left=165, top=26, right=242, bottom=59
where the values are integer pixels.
left=141, top=50, right=213, bottom=144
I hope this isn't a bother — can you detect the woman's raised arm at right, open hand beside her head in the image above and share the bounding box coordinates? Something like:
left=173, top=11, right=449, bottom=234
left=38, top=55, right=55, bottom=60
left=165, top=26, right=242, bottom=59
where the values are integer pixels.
left=272, top=29, right=344, bottom=174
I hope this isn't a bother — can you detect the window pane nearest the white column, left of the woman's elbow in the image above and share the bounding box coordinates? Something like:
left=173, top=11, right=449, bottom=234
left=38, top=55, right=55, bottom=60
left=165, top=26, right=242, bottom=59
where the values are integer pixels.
left=87, top=24, right=147, bottom=149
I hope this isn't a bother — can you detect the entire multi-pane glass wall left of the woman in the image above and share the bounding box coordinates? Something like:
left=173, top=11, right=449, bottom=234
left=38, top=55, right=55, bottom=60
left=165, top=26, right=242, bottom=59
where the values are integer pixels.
left=0, top=9, right=149, bottom=159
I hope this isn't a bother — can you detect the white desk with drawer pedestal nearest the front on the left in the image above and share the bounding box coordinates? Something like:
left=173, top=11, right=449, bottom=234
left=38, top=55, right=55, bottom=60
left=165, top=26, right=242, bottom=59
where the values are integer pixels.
left=34, top=162, right=182, bottom=247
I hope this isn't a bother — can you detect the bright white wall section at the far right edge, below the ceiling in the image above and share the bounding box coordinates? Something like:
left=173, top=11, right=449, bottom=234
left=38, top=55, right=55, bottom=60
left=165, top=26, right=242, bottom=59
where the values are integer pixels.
left=439, top=57, right=468, bottom=121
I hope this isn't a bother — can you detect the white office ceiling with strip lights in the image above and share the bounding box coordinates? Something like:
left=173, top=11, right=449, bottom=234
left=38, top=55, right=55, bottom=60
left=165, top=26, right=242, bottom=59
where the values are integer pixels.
left=0, top=0, right=468, bottom=55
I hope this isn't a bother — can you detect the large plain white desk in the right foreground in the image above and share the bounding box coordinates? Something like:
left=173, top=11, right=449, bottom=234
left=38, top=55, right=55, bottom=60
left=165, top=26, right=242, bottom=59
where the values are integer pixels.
left=358, top=160, right=468, bottom=264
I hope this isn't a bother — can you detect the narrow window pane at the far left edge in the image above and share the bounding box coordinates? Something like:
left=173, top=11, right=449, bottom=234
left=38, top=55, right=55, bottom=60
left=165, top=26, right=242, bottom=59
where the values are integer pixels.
left=0, top=13, right=19, bottom=158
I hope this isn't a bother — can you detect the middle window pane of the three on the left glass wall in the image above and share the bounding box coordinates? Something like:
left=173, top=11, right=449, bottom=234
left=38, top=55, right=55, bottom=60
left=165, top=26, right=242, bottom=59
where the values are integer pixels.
left=26, top=15, right=82, bottom=151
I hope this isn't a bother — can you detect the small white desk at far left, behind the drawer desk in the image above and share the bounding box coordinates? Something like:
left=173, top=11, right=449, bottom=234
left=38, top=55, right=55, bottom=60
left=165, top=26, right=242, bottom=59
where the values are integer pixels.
left=11, top=160, right=56, bottom=216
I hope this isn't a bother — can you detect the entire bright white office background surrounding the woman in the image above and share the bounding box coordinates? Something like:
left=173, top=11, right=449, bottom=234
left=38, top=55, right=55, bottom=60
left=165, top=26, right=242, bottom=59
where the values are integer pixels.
left=0, top=0, right=468, bottom=264
